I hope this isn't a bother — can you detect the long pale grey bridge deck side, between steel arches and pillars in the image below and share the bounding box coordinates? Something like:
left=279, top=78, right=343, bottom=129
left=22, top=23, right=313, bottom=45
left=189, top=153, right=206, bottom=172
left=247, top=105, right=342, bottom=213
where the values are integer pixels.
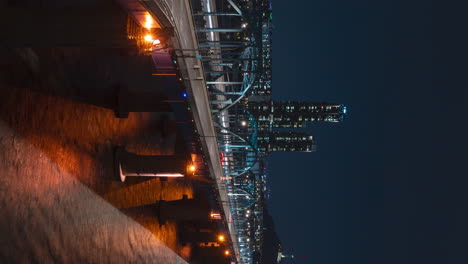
left=141, top=0, right=240, bottom=260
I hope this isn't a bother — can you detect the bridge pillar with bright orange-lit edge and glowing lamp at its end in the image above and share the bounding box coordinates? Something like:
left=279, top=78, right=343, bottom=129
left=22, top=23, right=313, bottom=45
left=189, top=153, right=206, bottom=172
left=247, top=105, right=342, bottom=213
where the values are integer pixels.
left=114, top=147, right=195, bottom=182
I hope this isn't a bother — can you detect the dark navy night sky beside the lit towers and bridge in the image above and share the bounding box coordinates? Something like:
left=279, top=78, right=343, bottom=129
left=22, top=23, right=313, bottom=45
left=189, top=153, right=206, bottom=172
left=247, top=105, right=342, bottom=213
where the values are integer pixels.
left=268, top=0, right=468, bottom=264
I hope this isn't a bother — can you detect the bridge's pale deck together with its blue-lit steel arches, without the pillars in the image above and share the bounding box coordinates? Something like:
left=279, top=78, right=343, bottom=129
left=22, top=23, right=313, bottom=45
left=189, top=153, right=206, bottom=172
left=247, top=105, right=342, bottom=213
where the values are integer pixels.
left=127, top=0, right=262, bottom=263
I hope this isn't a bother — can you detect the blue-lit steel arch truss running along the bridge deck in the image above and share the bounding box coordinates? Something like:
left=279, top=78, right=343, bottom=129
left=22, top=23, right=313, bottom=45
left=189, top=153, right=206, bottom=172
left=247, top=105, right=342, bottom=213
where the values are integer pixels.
left=187, top=0, right=261, bottom=263
